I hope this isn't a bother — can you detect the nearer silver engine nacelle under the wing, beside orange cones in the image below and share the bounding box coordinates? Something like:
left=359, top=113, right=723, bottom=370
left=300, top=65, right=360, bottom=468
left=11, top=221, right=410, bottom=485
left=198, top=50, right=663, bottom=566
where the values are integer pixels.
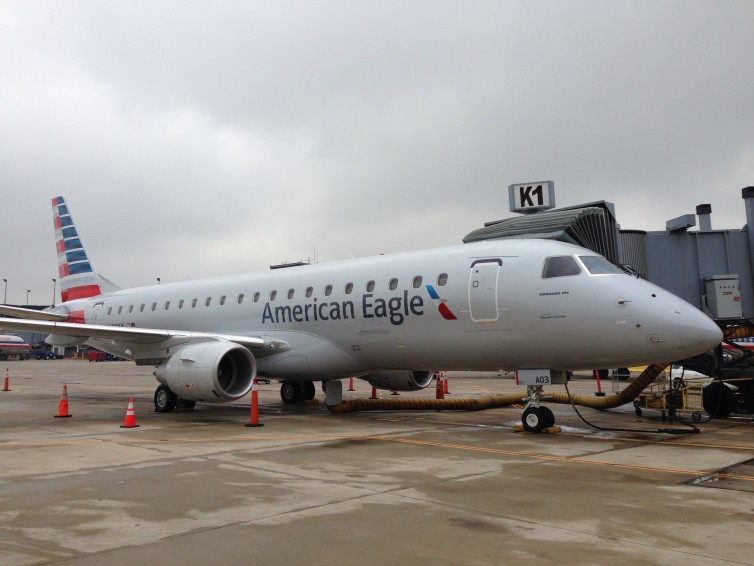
left=154, top=341, right=257, bottom=403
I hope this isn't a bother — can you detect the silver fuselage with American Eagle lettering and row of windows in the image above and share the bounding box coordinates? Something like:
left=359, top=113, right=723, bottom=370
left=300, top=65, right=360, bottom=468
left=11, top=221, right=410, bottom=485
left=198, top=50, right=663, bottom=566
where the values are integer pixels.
left=56, top=239, right=721, bottom=380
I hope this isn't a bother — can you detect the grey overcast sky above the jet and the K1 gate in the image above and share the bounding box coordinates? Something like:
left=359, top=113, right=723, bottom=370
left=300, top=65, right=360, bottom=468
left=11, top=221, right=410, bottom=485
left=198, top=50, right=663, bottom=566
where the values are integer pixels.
left=0, top=0, right=754, bottom=304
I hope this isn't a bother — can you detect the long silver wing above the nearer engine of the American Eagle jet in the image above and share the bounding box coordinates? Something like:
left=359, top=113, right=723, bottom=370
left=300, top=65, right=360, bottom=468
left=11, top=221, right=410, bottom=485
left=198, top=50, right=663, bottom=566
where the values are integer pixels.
left=0, top=318, right=291, bottom=353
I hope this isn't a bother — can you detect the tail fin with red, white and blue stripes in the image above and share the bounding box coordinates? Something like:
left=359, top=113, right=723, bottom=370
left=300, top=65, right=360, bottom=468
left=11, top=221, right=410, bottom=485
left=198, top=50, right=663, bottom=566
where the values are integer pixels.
left=52, top=197, right=102, bottom=302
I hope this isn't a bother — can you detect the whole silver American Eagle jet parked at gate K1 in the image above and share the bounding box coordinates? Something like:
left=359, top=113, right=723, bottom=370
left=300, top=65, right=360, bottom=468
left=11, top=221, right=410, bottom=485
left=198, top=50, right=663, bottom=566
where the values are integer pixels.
left=0, top=197, right=722, bottom=432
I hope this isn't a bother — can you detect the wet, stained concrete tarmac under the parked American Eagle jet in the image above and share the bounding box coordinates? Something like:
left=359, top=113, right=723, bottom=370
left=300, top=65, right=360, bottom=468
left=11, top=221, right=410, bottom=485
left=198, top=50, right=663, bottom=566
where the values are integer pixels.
left=0, top=360, right=754, bottom=566
